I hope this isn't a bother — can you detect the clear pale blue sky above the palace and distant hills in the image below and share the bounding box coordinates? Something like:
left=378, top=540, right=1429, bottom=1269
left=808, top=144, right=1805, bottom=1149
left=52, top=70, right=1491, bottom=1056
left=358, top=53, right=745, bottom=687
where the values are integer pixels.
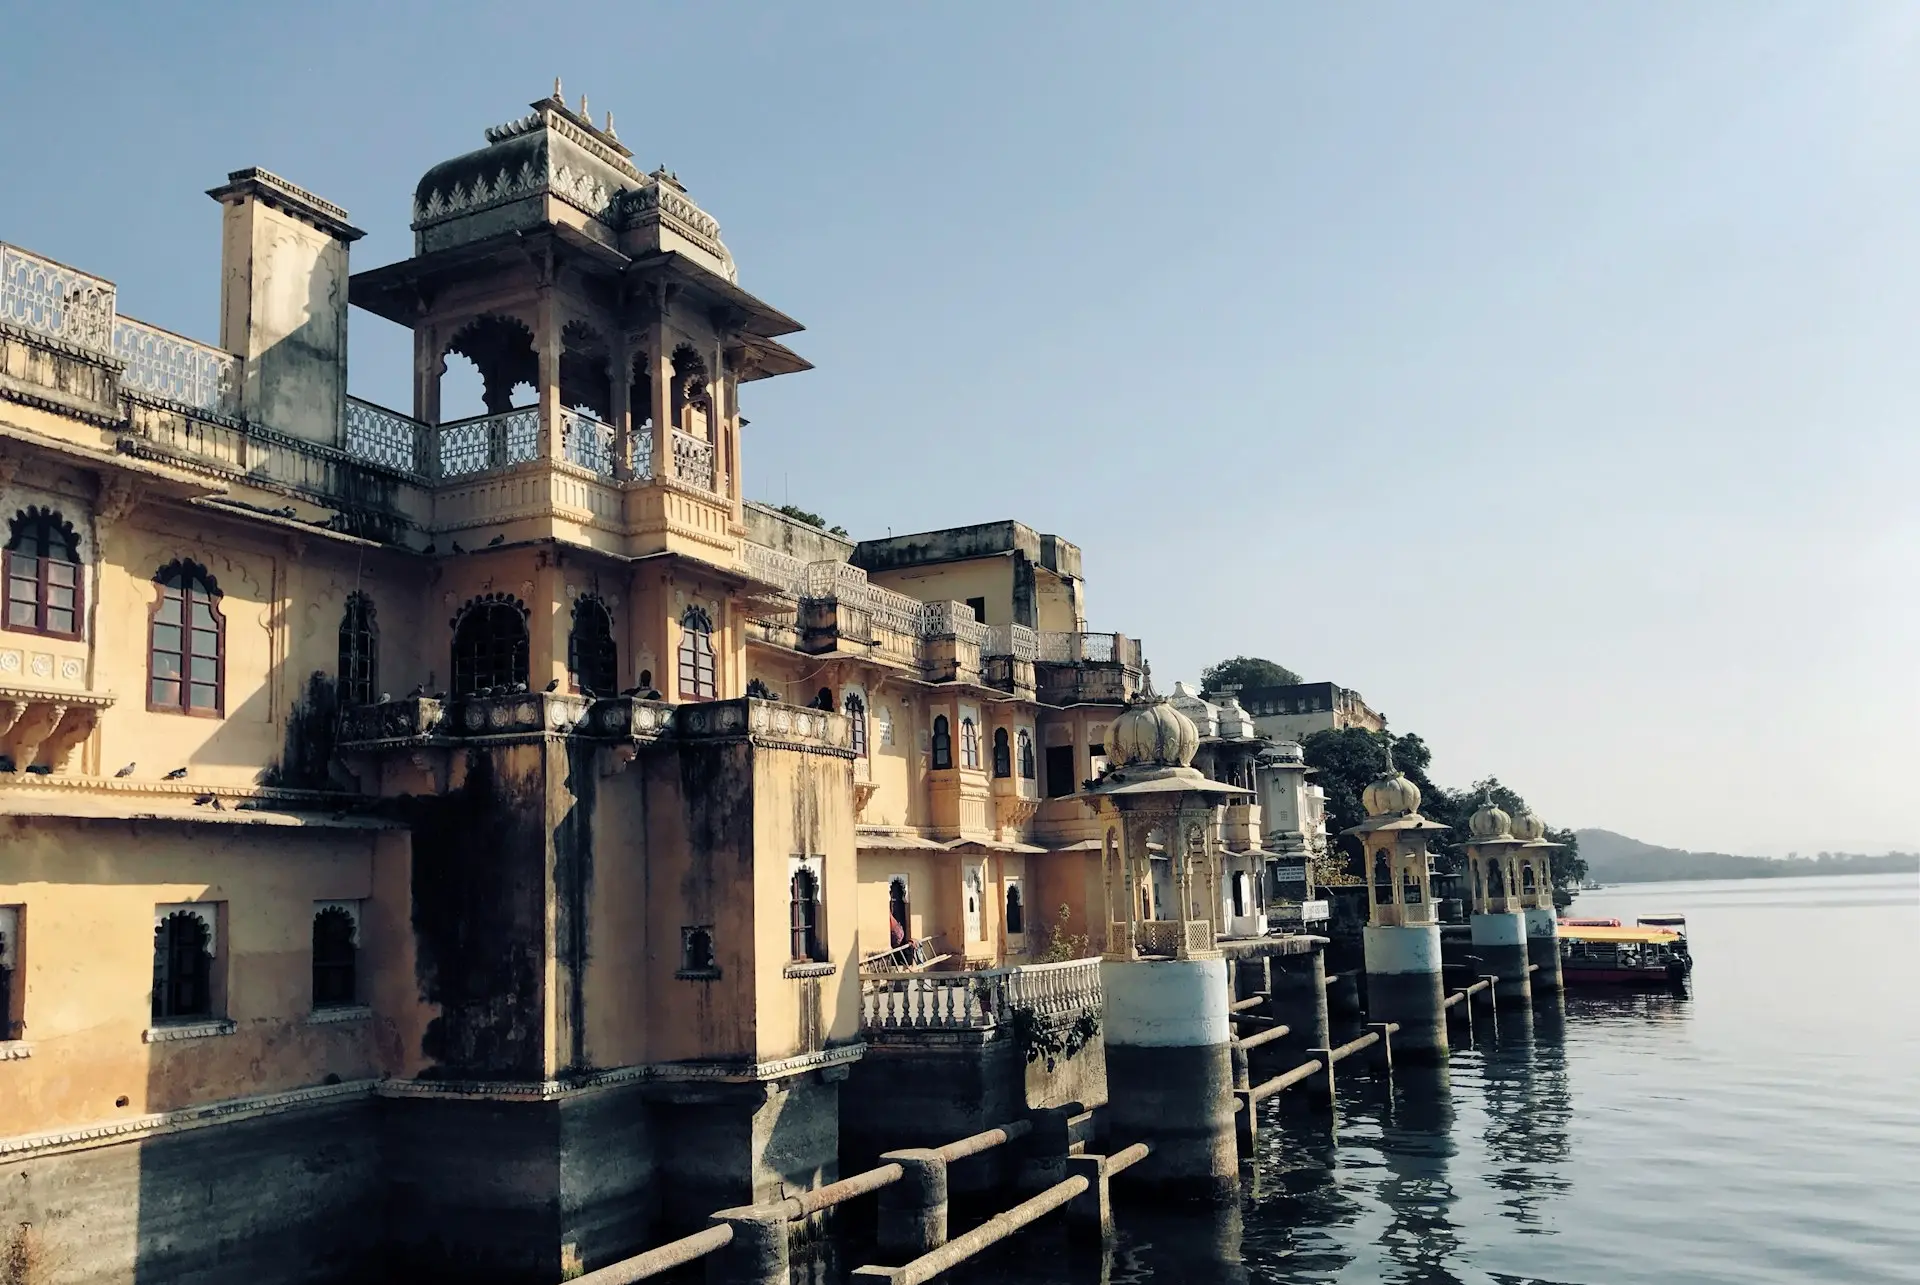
left=0, top=0, right=1920, bottom=853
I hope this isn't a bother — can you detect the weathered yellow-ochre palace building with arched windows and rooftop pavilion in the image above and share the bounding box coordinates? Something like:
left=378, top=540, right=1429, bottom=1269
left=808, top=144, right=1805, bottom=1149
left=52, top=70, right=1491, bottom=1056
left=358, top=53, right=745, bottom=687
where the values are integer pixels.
left=0, top=94, right=1325, bottom=1281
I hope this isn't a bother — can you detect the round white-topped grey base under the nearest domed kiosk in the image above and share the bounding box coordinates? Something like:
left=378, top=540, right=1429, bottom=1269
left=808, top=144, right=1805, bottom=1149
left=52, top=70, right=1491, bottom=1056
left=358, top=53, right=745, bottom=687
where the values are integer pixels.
left=1100, top=958, right=1240, bottom=1204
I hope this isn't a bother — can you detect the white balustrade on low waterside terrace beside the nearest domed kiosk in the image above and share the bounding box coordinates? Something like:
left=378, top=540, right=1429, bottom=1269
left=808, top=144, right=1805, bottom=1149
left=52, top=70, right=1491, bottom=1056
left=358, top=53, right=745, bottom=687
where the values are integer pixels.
left=860, top=958, right=1104, bottom=1031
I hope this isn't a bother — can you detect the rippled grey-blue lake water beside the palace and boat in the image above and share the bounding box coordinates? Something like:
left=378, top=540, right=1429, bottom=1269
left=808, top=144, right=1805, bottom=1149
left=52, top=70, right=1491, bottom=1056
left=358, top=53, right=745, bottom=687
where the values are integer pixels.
left=921, top=876, right=1920, bottom=1285
